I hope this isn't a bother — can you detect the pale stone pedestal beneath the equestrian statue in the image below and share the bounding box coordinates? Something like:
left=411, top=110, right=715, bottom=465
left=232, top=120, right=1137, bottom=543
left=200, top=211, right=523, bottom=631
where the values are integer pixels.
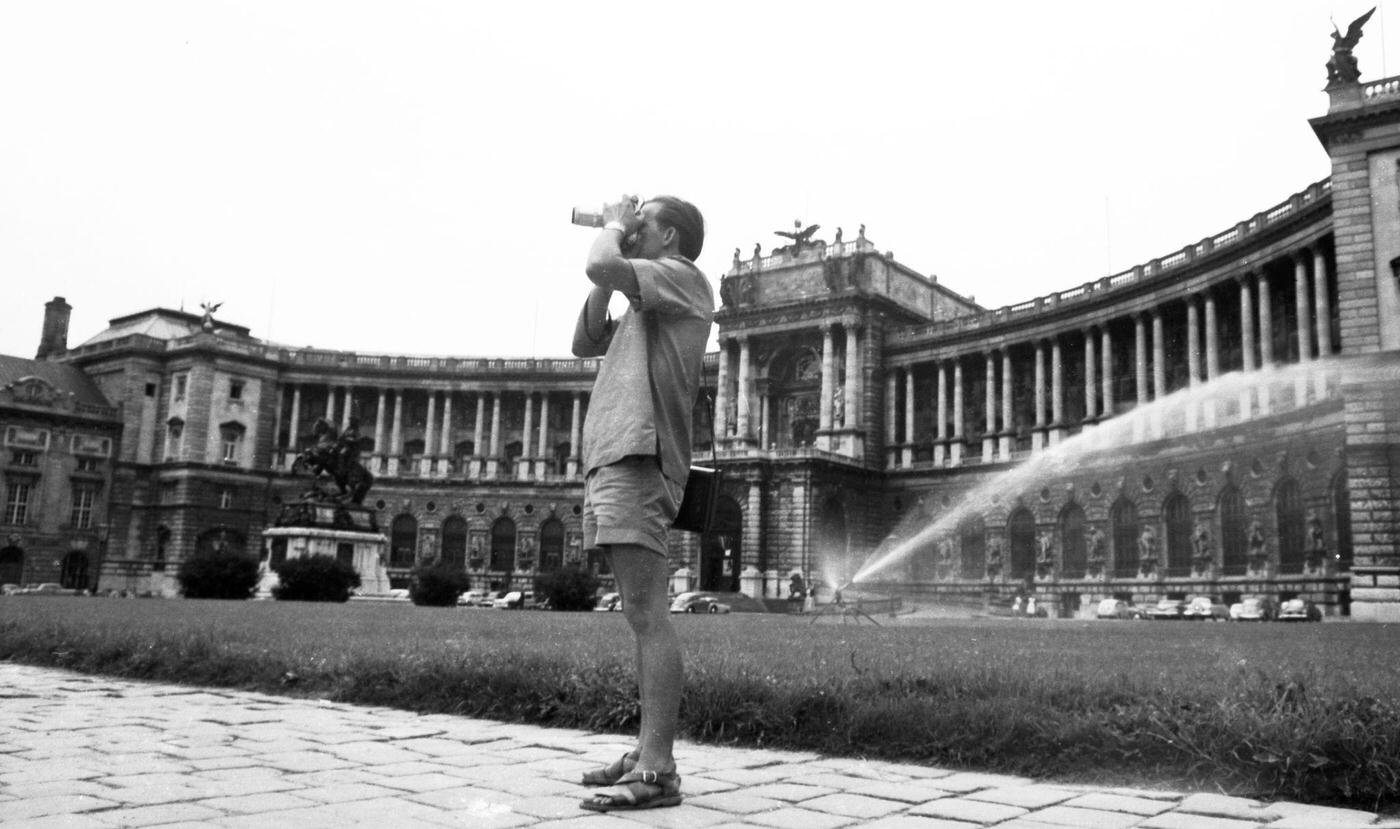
left=258, top=501, right=391, bottom=598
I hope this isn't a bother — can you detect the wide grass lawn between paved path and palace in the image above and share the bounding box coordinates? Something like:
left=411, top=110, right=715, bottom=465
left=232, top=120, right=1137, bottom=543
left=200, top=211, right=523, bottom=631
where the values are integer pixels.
left=0, top=597, right=1400, bottom=808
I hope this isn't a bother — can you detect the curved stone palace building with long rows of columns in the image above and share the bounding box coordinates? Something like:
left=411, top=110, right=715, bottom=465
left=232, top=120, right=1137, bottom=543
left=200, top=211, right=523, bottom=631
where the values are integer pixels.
left=8, top=50, right=1400, bottom=620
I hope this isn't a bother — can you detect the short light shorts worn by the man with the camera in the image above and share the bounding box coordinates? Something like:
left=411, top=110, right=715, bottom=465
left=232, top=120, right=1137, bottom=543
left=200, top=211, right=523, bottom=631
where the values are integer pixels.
left=584, top=455, right=685, bottom=556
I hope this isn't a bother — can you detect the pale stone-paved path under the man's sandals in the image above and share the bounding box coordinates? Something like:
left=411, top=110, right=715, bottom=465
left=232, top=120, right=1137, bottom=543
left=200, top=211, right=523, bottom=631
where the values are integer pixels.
left=0, top=664, right=1400, bottom=829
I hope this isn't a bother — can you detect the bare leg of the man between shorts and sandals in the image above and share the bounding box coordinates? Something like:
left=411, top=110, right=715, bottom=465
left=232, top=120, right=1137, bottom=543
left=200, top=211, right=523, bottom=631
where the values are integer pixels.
left=610, top=545, right=685, bottom=773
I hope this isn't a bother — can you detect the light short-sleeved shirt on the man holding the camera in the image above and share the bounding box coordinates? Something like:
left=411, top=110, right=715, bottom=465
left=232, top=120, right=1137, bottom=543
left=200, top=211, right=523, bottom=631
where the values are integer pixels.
left=582, top=256, right=714, bottom=485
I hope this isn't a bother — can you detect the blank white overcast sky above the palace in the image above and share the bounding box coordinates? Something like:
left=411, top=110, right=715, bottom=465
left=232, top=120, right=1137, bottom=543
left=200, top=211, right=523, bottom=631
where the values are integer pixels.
left=0, top=0, right=1400, bottom=357
